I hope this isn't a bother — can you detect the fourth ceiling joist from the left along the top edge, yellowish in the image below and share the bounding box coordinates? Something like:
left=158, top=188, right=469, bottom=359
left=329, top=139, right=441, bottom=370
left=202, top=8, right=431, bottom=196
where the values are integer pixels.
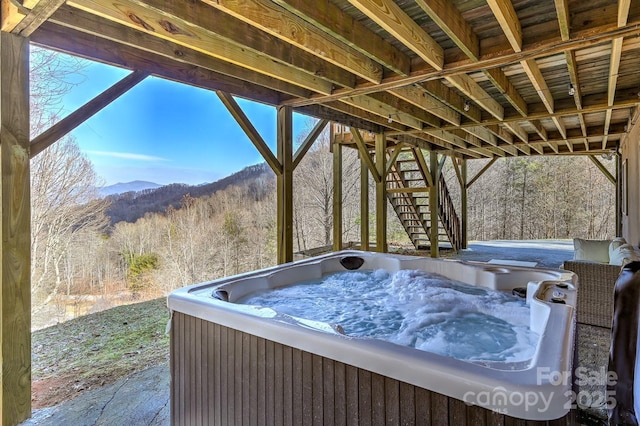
left=349, top=0, right=444, bottom=70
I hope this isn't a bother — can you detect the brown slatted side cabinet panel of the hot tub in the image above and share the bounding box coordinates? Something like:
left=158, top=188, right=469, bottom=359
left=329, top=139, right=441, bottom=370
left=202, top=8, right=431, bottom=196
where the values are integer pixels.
left=171, top=312, right=572, bottom=426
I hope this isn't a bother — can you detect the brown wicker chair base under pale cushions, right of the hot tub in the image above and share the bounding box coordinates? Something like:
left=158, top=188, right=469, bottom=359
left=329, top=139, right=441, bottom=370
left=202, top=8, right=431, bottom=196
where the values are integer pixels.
left=562, top=260, right=622, bottom=328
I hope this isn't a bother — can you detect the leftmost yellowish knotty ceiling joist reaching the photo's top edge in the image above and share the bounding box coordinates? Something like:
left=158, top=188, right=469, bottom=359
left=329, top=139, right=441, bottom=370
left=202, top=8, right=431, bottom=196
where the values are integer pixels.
left=67, top=0, right=332, bottom=94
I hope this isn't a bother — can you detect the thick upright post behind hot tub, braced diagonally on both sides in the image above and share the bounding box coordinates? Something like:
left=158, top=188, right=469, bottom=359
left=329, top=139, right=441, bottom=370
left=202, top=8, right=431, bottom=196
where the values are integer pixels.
left=276, top=106, right=293, bottom=264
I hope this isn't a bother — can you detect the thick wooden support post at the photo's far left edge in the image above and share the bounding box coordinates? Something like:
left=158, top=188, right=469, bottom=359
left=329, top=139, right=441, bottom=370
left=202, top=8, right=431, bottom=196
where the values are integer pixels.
left=0, top=32, right=31, bottom=426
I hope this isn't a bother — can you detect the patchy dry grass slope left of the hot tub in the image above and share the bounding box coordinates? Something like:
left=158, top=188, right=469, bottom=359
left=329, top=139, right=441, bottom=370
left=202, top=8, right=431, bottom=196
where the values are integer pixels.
left=32, top=298, right=169, bottom=408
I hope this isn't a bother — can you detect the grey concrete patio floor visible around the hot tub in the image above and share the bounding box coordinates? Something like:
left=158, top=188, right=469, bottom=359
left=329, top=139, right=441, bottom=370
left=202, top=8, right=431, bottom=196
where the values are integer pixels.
left=23, top=240, right=609, bottom=426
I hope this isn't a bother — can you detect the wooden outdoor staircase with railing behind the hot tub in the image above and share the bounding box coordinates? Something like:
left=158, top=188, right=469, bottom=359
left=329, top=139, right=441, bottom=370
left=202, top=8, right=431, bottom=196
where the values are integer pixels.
left=387, top=148, right=462, bottom=250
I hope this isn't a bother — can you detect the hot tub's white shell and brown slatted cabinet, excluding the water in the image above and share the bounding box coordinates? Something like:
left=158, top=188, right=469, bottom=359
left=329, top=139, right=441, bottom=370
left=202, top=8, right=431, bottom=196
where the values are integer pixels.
left=168, top=251, right=576, bottom=425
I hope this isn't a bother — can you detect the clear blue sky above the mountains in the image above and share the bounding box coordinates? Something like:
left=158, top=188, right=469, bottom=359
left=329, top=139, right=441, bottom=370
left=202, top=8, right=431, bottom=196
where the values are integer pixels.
left=57, top=54, right=311, bottom=185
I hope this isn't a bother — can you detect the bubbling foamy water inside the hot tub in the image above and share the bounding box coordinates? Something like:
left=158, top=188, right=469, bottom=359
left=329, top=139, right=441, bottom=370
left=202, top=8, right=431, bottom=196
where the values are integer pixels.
left=236, top=270, right=540, bottom=362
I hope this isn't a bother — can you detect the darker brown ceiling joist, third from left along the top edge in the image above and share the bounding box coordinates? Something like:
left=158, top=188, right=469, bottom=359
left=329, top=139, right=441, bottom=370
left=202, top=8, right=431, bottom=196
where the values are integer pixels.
left=274, top=0, right=411, bottom=75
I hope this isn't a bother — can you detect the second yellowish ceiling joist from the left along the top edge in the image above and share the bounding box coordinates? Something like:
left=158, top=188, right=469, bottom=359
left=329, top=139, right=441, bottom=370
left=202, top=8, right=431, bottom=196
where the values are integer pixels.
left=204, top=0, right=382, bottom=83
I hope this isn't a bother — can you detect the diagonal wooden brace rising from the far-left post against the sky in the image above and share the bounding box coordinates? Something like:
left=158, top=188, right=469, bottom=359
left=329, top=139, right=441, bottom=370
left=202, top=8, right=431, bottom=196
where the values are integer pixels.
left=30, top=71, right=148, bottom=158
